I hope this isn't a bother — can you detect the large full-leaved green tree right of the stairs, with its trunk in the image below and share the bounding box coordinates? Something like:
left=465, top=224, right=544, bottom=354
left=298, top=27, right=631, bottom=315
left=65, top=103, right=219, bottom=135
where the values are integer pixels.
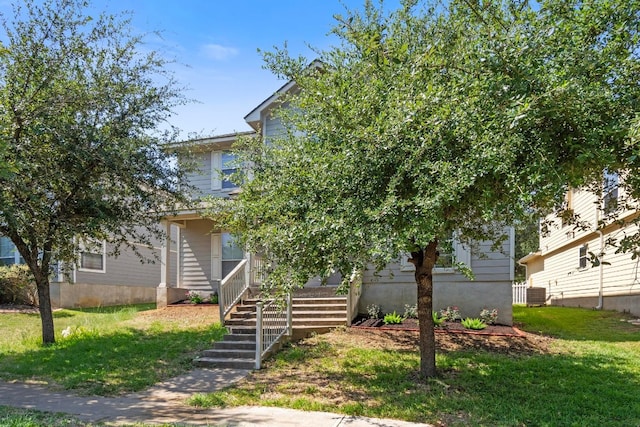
left=216, top=0, right=640, bottom=376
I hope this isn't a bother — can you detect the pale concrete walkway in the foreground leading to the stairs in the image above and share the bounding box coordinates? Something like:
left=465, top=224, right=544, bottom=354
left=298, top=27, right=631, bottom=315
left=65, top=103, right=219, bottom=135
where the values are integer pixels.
left=0, top=369, right=429, bottom=427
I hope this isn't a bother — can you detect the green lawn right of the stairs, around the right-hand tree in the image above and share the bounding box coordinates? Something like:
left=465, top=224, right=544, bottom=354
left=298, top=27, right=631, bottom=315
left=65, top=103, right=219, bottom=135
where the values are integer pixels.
left=191, top=307, right=640, bottom=426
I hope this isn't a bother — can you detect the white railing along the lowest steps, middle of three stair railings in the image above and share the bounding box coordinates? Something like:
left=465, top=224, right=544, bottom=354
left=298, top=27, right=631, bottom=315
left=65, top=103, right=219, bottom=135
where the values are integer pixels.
left=256, top=294, right=293, bottom=369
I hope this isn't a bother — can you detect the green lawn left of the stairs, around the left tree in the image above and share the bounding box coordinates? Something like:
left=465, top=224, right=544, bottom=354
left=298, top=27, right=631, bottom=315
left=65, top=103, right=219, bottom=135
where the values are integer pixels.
left=0, top=305, right=224, bottom=396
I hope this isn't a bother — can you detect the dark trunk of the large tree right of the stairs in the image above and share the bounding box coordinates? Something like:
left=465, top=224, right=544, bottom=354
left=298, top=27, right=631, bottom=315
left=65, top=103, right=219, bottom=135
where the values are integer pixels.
left=410, top=240, right=438, bottom=378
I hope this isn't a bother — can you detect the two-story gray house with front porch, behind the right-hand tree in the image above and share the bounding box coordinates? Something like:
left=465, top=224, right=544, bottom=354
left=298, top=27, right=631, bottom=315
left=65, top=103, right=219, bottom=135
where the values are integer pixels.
left=158, top=82, right=514, bottom=324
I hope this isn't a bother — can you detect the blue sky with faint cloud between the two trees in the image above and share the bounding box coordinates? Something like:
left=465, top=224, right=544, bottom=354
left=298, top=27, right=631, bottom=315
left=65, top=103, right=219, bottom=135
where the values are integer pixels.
left=0, top=0, right=398, bottom=137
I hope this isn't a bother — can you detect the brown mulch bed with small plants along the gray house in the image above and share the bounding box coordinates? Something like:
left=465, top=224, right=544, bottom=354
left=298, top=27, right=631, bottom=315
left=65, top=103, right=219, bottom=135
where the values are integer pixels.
left=351, top=317, right=525, bottom=337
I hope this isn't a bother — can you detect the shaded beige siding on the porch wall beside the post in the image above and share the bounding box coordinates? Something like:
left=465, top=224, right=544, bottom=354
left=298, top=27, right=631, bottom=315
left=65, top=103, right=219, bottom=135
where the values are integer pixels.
left=180, top=220, right=217, bottom=291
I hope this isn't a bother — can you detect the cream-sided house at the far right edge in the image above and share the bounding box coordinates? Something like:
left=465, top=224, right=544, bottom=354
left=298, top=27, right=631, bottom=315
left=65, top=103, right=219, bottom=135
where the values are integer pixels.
left=519, top=173, right=640, bottom=315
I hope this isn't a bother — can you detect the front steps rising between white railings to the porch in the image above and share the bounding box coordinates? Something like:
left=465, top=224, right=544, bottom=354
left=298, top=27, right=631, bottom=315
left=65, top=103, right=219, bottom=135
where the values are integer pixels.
left=194, top=288, right=347, bottom=369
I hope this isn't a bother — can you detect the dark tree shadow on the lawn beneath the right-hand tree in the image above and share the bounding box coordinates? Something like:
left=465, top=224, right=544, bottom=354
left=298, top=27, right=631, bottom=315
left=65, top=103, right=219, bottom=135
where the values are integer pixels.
left=333, top=351, right=640, bottom=426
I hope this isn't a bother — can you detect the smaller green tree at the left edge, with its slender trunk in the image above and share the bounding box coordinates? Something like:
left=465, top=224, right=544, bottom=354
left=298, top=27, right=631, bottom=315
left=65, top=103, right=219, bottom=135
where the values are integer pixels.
left=0, top=0, right=191, bottom=343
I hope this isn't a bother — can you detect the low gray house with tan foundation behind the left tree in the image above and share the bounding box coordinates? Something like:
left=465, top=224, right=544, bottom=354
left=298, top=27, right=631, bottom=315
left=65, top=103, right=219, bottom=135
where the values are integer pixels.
left=0, top=237, right=175, bottom=308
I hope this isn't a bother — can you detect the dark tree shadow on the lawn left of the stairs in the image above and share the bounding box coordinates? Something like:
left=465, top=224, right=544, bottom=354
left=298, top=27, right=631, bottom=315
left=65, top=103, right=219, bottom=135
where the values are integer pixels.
left=0, top=324, right=225, bottom=396
